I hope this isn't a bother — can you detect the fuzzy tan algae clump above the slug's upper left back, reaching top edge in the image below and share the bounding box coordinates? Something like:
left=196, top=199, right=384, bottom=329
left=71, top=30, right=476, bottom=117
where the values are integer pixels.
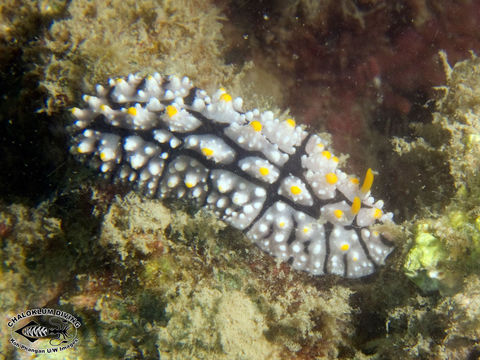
left=41, top=0, right=284, bottom=112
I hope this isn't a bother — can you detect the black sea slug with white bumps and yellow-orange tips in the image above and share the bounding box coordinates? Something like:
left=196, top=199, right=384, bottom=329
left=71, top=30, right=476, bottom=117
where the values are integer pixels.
left=71, top=73, right=393, bottom=278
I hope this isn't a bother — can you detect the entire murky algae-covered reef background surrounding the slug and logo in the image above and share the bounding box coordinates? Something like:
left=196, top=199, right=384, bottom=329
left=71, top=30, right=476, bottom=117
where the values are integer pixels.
left=0, top=0, right=480, bottom=359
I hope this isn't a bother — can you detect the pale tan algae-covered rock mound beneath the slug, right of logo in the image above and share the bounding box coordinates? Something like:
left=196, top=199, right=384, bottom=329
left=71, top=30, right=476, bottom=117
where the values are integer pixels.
left=100, top=194, right=352, bottom=359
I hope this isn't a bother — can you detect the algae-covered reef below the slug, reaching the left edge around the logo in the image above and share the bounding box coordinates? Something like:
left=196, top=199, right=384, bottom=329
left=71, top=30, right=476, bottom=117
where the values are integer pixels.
left=0, top=193, right=354, bottom=359
